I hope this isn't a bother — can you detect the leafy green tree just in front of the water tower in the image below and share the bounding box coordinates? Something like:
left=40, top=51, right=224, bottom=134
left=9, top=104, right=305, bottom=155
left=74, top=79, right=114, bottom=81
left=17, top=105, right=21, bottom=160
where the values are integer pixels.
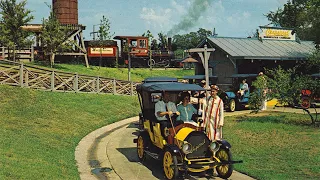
left=41, top=6, right=74, bottom=67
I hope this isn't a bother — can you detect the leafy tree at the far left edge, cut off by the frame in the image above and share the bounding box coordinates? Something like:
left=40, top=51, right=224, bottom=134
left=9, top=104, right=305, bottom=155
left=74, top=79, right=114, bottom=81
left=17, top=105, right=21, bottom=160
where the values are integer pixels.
left=0, top=0, right=34, bottom=60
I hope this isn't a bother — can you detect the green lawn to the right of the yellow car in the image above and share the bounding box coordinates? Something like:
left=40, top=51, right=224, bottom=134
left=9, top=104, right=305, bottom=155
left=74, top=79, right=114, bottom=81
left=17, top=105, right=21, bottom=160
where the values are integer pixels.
left=224, top=113, right=320, bottom=179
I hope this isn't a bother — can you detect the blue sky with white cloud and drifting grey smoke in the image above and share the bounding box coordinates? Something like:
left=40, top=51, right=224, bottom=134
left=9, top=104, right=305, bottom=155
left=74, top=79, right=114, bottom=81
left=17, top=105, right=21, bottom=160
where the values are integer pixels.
left=26, top=0, right=287, bottom=40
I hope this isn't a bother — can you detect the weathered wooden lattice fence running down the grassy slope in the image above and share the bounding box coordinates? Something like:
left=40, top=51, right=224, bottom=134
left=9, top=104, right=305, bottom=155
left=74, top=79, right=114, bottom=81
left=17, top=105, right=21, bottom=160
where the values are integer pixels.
left=0, top=60, right=138, bottom=96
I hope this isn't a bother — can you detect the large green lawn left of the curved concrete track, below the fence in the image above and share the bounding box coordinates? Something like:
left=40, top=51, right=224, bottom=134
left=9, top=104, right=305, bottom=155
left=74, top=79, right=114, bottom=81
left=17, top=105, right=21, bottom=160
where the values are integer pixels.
left=0, top=85, right=139, bottom=180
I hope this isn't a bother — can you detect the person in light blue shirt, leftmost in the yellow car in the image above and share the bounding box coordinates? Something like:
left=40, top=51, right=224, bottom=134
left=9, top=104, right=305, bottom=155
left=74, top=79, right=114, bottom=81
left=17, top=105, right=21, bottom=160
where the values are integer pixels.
left=155, top=92, right=180, bottom=132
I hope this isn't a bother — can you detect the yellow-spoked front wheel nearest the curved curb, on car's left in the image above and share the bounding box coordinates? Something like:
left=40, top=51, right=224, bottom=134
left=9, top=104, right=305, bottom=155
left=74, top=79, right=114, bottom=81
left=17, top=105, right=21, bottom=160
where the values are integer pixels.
left=163, top=150, right=179, bottom=180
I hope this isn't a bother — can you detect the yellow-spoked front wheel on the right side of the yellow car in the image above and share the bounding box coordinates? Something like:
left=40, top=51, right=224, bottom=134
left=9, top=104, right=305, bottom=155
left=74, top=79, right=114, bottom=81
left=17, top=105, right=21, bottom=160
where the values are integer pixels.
left=216, top=148, right=233, bottom=179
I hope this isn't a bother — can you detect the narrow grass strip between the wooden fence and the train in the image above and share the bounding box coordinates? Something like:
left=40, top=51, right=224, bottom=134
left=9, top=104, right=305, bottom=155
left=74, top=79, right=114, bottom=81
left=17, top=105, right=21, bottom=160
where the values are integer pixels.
left=31, top=64, right=194, bottom=82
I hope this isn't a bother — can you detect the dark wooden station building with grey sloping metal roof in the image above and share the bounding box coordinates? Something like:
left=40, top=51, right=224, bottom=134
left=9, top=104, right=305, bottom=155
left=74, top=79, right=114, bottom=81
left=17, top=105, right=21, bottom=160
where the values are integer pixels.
left=193, top=32, right=315, bottom=90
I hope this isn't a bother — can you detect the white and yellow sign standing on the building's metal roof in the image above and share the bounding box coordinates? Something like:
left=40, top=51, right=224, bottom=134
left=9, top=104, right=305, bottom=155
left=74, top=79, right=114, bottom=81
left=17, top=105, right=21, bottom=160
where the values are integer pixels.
left=259, top=27, right=296, bottom=40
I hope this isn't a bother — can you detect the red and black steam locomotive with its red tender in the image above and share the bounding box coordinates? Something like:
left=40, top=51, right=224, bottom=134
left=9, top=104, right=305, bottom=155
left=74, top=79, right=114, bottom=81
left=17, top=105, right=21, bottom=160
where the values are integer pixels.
left=85, top=36, right=174, bottom=67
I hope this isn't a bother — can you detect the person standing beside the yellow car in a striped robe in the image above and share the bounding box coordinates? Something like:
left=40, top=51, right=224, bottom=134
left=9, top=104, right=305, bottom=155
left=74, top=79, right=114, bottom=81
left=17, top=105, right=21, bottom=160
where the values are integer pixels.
left=202, top=85, right=224, bottom=141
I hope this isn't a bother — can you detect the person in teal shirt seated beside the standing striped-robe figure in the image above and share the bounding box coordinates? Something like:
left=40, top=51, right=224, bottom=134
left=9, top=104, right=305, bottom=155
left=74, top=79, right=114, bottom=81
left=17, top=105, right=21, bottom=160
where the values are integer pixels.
left=177, top=92, right=197, bottom=125
